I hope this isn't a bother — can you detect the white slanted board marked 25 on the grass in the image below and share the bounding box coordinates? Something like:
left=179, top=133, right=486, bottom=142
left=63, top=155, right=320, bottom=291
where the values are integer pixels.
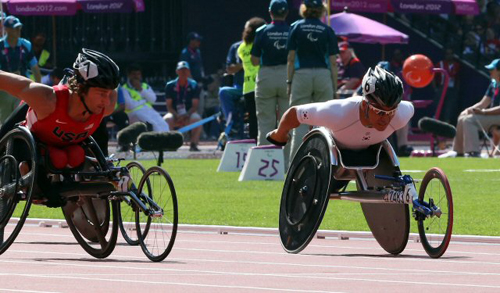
left=238, top=145, right=285, bottom=181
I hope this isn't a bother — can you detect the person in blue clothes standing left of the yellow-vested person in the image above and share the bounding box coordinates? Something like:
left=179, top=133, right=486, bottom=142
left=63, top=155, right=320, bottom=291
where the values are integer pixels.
left=219, top=41, right=244, bottom=138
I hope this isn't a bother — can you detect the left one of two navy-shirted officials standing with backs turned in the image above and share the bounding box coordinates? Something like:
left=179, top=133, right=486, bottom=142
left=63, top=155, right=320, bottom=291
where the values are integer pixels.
left=251, top=0, right=290, bottom=149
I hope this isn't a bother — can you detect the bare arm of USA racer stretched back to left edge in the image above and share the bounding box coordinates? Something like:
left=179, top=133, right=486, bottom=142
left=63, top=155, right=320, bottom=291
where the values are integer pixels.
left=0, top=70, right=56, bottom=117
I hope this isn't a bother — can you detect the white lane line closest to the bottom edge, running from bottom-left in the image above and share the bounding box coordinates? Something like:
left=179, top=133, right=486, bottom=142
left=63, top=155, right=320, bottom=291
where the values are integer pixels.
left=0, top=273, right=341, bottom=293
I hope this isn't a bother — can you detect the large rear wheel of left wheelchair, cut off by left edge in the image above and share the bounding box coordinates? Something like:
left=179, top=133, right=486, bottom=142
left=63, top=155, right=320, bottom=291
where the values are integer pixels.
left=0, top=127, right=37, bottom=254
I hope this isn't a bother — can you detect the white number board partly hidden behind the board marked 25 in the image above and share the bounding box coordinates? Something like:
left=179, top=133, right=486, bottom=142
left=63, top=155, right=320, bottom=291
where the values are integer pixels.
left=217, top=139, right=257, bottom=172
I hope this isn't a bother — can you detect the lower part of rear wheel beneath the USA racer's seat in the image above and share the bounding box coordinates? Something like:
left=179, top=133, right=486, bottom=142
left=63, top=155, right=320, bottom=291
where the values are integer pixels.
left=63, top=197, right=118, bottom=258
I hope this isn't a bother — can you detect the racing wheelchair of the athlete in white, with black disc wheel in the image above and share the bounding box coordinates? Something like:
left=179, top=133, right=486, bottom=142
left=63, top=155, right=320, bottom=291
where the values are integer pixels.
left=279, top=128, right=453, bottom=258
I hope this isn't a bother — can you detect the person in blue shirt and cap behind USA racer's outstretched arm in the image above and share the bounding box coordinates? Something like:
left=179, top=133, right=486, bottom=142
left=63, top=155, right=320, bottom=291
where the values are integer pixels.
left=0, top=15, right=42, bottom=123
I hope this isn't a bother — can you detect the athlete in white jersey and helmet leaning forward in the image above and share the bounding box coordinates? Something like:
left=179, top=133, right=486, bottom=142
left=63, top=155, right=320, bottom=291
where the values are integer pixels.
left=267, top=66, right=414, bottom=150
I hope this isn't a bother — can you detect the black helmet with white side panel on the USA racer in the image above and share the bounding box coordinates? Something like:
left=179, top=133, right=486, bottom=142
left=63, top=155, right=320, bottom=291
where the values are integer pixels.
left=73, top=48, right=120, bottom=89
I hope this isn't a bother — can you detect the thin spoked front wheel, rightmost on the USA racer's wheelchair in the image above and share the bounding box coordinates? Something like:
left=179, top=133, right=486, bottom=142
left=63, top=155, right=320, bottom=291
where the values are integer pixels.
left=135, top=166, right=178, bottom=261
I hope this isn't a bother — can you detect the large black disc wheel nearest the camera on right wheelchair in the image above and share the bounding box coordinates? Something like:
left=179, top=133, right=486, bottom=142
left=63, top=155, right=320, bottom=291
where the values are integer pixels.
left=279, top=131, right=332, bottom=253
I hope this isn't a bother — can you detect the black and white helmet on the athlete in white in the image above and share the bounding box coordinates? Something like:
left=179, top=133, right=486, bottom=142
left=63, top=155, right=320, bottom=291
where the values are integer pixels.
left=362, top=66, right=403, bottom=108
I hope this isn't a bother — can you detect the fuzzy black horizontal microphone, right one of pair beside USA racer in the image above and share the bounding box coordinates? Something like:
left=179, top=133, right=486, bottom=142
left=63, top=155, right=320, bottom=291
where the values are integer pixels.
left=137, top=131, right=184, bottom=151
